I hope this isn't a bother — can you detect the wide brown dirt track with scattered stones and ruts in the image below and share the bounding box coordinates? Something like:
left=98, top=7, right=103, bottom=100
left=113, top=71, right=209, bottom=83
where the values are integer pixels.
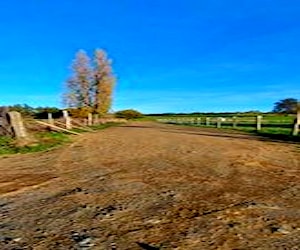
left=0, top=122, right=300, bottom=250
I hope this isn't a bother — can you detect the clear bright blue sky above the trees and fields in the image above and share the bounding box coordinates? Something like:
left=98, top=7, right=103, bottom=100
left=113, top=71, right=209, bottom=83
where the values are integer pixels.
left=0, top=0, right=300, bottom=113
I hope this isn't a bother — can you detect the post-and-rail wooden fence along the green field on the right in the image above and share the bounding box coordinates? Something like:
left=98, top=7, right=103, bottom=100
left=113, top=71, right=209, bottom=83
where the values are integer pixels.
left=157, top=112, right=300, bottom=136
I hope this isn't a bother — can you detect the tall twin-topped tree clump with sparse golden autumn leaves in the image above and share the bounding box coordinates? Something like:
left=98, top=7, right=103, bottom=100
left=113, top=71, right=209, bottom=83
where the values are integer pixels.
left=64, top=49, right=115, bottom=116
